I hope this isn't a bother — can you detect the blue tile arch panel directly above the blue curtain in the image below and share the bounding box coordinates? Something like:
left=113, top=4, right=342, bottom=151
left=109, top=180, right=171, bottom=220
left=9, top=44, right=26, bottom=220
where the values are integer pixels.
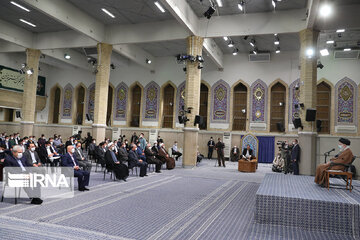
left=250, top=79, right=268, bottom=123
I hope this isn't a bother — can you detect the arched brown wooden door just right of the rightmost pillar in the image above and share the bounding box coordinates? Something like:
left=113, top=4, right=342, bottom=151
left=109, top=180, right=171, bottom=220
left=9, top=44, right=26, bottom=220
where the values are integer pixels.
left=316, top=82, right=331, bottom=133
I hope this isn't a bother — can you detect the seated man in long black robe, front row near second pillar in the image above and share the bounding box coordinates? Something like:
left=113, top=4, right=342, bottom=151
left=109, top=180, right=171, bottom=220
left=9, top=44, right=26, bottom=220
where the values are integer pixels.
left=105, top=142, right=129, bottom=182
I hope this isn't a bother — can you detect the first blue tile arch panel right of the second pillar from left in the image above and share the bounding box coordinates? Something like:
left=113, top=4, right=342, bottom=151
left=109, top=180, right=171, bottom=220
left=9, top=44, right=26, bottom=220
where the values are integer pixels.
left=113, top=82, right=129, bottom=121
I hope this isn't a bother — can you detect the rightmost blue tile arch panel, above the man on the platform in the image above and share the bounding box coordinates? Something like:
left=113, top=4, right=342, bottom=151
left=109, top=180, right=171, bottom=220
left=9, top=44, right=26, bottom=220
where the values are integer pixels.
left=335, top=77, right=358, bottom=126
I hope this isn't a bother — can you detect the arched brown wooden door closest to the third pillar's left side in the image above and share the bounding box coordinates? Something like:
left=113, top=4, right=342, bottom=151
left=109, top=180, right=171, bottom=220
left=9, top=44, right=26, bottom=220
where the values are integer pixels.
left=162, top=84, right=175, bottom=128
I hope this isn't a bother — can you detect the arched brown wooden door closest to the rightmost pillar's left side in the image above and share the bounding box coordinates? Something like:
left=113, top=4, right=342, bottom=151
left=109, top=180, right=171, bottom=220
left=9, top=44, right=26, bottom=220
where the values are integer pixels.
left=269, top=83, right=286, bottom=132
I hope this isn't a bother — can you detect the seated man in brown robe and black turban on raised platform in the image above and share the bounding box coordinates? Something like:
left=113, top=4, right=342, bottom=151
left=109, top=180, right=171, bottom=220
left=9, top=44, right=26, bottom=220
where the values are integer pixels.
left=315, top=138, right=353, bottom=187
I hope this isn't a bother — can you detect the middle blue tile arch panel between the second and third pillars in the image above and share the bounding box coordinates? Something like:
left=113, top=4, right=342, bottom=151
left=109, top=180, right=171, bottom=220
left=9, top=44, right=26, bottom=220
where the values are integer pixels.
left=143, top=81, right=160, bottom=121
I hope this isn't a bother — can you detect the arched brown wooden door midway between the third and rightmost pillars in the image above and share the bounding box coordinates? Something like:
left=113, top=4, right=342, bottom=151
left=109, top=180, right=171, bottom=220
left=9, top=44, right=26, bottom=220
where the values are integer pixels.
left=233, top=83, right=247, bottom=131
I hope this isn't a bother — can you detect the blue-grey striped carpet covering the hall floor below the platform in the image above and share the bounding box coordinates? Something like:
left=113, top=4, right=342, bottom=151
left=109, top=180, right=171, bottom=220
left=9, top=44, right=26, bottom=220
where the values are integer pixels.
left=0, top=160, right=360, bottom=240
